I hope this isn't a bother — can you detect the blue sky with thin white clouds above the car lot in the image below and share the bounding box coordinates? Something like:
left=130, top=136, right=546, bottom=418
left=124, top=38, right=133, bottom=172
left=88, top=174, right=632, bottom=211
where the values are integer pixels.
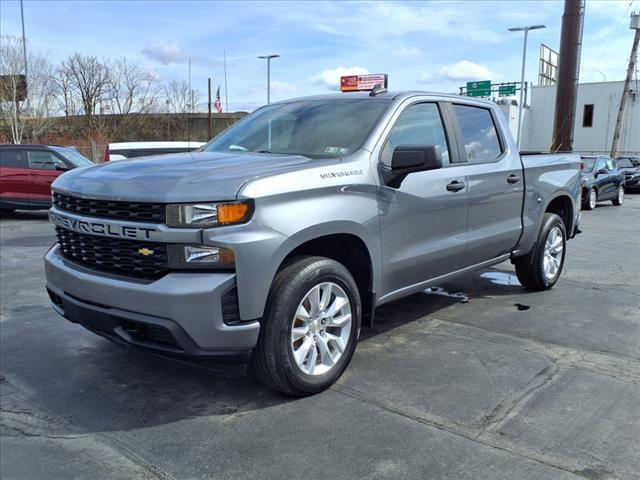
left=0, top=0, right=640, bottom=110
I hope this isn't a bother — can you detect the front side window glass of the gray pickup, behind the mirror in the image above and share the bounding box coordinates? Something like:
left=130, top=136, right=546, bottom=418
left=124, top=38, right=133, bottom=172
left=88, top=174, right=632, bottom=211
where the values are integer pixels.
left=381, top=103, right=449, bottom=166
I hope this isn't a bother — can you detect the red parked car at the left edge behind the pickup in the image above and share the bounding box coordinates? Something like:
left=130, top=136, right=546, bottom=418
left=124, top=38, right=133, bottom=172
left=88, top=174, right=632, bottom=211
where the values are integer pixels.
left=0, top=145, right=94, bottom=212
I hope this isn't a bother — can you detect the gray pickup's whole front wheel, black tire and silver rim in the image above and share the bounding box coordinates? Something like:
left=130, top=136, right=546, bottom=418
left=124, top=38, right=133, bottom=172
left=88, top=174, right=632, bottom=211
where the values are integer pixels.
left=250, top=256, right=362, bottom=397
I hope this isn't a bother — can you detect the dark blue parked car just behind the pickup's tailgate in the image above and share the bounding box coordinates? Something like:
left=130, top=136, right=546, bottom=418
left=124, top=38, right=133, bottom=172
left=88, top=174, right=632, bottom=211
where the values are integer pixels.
left=582, top=155, right=624, bottom=210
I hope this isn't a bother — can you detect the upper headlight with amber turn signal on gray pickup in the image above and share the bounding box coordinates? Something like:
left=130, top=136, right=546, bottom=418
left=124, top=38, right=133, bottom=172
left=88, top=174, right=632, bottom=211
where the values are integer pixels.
left=166, top=201, right=251, bottom=228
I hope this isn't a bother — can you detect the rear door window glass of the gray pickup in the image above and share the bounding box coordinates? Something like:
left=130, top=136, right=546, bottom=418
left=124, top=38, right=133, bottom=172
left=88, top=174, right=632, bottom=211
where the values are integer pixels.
left=453, top=105, right=502, bottom=163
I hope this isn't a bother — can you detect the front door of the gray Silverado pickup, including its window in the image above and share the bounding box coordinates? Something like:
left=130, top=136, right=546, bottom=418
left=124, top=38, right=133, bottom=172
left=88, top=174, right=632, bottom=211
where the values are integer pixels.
left=379, top=103, right=467, bottom=296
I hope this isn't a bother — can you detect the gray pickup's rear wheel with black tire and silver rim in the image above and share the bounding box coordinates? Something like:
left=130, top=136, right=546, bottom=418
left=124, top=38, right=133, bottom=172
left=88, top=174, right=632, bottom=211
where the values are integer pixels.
left=514, top=213, right=567, bottom=290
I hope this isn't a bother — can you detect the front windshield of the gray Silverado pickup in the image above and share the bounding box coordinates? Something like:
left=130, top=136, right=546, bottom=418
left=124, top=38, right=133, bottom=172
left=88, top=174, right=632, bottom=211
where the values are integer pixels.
left=203, top=98, right=390, bottom=158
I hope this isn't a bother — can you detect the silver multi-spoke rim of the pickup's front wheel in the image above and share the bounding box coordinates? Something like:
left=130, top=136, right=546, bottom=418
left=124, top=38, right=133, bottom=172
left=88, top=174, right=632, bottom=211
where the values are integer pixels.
left=291, top=282, right=352, bottom=375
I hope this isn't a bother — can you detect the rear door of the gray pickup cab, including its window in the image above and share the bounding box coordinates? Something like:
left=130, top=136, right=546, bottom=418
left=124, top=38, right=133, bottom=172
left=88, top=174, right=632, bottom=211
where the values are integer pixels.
left=453, top=104, right=524, bottom=267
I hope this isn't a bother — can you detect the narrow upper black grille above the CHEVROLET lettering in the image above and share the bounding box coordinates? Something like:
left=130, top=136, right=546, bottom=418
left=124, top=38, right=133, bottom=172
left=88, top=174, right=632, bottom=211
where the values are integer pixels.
left=53, top=192, right=166, bottom=223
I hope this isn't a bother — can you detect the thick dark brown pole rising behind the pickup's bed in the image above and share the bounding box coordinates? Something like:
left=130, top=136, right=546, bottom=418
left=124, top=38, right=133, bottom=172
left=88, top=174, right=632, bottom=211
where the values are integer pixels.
left=551, top=0, right=584, bottom=152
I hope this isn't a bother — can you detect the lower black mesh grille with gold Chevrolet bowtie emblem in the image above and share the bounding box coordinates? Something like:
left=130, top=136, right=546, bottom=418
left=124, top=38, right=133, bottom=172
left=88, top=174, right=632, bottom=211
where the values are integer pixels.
left=56, top=227, right=169, bottom=278
